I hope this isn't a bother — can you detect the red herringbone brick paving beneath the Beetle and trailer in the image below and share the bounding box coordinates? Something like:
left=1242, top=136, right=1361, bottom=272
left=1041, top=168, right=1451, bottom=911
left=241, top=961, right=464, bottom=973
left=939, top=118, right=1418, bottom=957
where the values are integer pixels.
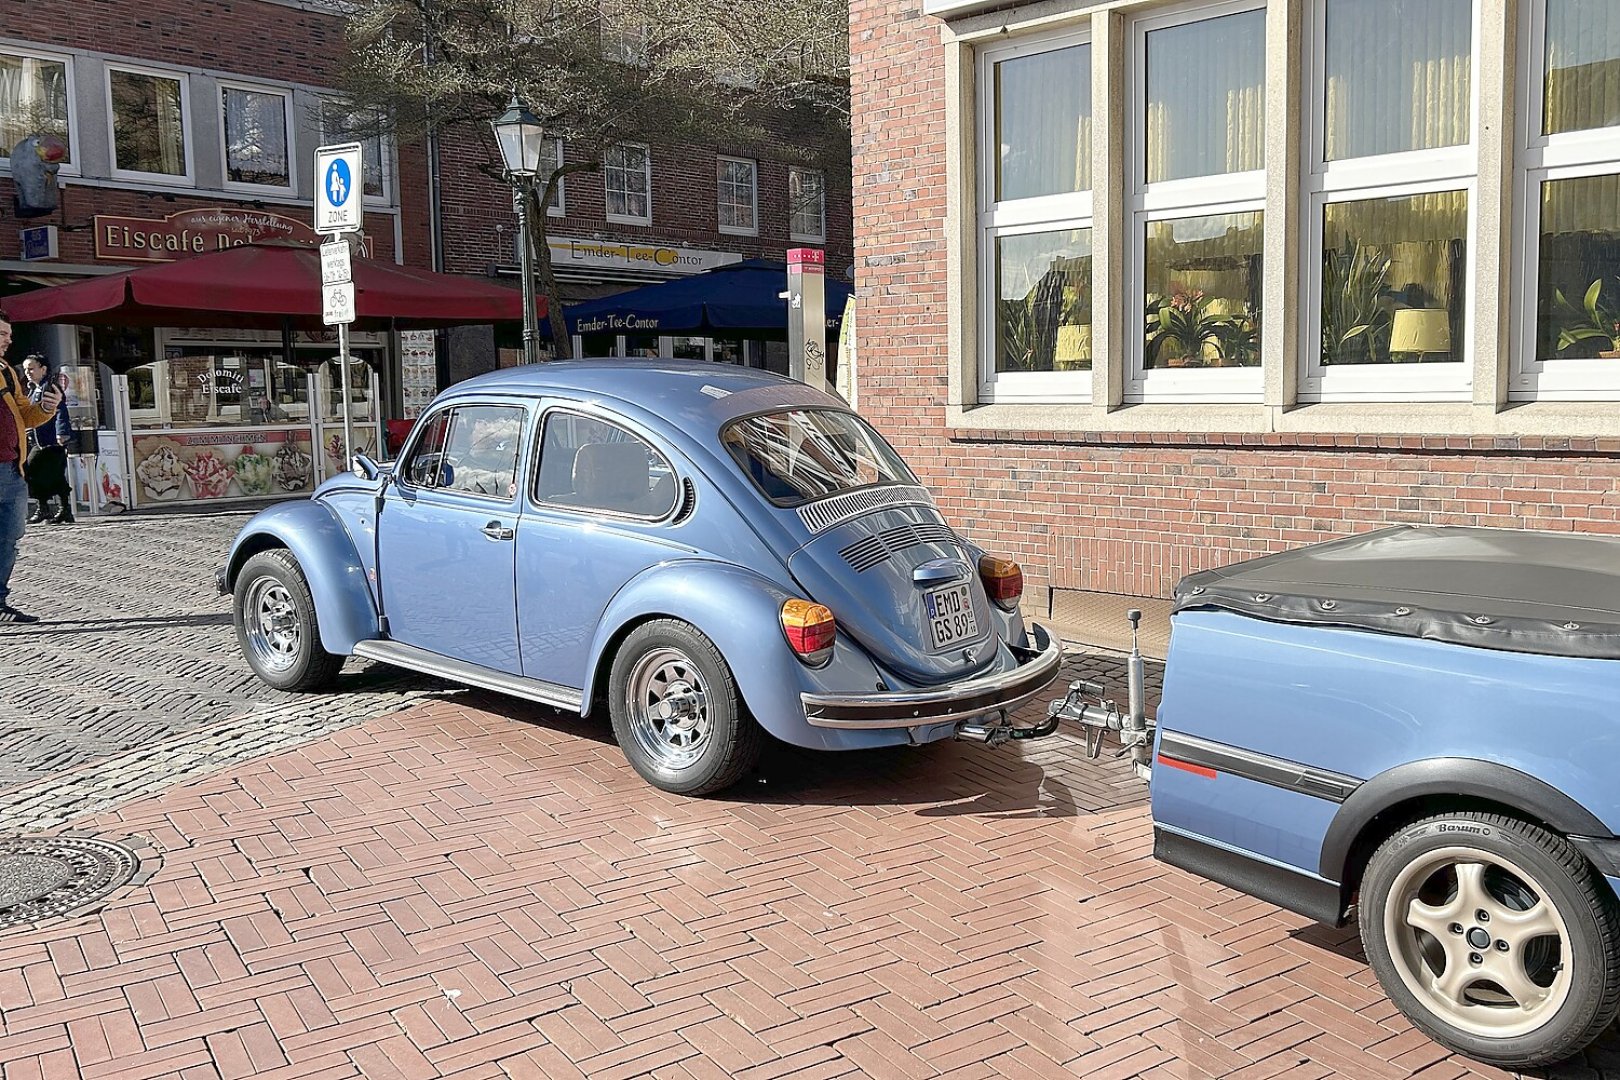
left=0, top=696, right=1620, bottom=1080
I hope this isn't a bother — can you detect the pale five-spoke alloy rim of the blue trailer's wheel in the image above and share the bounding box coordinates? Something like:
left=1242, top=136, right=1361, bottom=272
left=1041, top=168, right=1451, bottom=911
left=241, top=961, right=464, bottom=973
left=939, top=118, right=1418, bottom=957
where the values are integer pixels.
left=1383, top=847, right=1580, bottom=1038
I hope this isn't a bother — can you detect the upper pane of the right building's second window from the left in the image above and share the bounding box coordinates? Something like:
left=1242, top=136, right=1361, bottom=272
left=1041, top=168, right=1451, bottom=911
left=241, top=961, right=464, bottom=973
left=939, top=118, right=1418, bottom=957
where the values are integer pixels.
left=1145, top=11, right=1265, bottom=183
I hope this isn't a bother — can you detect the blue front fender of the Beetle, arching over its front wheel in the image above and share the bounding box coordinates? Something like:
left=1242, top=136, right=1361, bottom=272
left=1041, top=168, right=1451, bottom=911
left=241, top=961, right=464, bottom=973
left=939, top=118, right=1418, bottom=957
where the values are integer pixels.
left=225, top=499, right=379, bottom=656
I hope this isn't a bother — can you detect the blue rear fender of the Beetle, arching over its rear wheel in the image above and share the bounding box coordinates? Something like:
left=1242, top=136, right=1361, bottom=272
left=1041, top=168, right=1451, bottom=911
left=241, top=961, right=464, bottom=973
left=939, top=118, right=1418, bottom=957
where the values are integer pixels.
left=583, top=559, right=881, bottom=746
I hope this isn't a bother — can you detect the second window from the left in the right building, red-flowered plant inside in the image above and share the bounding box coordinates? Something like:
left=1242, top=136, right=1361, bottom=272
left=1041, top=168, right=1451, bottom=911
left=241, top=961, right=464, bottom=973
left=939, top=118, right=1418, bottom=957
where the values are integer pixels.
left=1128, top=3, right=1265, bottom=400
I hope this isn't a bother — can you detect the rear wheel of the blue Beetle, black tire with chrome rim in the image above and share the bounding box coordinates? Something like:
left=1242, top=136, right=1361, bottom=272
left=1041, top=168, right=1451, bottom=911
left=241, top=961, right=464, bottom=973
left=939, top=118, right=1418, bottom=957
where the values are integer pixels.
left=608, top=619, right=765, bottom=795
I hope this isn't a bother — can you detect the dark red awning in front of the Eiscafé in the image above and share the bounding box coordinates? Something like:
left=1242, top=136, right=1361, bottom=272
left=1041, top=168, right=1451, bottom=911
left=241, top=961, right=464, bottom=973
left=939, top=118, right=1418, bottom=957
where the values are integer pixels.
left=3, top=243, right=531, bottom=330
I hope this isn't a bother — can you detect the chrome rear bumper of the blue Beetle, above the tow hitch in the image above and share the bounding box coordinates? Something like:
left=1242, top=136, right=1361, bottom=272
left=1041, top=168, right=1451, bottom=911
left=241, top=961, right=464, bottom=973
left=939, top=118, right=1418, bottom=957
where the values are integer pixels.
left=799, top=623, right=1063, bottom=742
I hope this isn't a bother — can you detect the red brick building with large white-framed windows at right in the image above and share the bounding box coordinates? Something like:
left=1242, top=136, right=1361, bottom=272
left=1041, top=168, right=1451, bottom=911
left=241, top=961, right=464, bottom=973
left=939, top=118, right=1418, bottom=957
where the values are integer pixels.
left=851, top=0, right=1620, bottom=647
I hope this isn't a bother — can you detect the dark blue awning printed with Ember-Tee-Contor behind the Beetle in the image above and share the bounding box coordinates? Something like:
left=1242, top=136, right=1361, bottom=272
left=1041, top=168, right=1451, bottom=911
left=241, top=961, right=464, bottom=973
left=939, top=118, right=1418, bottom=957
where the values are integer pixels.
left=564, top=259, right=852, bottom=335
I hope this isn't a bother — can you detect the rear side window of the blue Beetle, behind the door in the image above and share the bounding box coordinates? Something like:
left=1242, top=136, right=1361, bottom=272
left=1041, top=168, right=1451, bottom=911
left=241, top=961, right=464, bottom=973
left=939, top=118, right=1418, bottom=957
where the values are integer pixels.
left=535, top=410, right=676, bottom=518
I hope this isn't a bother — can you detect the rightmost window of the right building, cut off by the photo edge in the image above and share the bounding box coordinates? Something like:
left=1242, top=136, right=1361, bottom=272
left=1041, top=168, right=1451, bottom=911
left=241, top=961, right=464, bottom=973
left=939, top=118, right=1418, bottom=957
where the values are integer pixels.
left=1510, top=0, right=1620, bottom=400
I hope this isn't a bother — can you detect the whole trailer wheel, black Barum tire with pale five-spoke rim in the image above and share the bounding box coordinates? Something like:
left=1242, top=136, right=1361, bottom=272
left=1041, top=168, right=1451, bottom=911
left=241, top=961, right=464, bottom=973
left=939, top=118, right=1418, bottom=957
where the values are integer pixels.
left=1359, top=811, right=1620, bottom=1069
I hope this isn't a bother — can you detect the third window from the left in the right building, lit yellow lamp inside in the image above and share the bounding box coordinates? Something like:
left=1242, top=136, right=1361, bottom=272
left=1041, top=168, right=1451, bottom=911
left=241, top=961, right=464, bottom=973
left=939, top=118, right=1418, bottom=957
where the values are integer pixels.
left=1299, top=0, right=1476, bottom=402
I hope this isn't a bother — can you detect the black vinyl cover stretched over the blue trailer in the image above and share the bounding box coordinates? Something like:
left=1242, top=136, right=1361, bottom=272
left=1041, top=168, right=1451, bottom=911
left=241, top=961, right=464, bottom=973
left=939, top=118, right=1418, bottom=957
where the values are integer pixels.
left=1175, top=525, right=1620, bottom=659
